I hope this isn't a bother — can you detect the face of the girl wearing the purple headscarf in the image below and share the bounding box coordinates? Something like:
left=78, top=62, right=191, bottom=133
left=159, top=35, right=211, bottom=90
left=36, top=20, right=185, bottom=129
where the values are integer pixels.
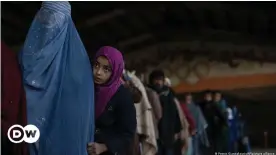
left=93, top=56, right=112, bottom=85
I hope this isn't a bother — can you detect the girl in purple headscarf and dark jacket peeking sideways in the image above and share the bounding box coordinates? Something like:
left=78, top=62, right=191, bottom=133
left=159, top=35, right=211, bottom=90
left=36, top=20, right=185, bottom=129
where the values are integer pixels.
left=87, top=46, right=137, bottom=155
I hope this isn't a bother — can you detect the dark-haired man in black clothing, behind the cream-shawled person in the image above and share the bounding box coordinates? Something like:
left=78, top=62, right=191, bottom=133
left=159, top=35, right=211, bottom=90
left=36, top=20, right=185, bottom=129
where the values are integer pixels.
left=148, top=70, right=181, bottom=155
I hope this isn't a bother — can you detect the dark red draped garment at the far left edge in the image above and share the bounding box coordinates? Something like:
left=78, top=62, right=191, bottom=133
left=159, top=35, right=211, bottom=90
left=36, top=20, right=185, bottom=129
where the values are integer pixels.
left=1, top=41, right=27, bottom=155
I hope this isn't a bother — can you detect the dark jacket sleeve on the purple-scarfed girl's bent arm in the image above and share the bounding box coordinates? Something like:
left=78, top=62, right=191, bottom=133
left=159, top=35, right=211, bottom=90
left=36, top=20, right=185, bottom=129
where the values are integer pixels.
left=105, top=88, right=137, bottom=154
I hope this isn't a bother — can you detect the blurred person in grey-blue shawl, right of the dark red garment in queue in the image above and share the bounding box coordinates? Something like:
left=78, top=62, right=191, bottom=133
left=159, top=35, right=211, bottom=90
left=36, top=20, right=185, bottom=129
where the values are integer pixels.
left=185, top=93, right=210, bottom=155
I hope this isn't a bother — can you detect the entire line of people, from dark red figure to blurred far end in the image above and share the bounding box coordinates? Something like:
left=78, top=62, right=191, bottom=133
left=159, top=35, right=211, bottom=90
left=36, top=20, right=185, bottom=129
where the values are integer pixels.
left=1, top=1, right=250, bottom=155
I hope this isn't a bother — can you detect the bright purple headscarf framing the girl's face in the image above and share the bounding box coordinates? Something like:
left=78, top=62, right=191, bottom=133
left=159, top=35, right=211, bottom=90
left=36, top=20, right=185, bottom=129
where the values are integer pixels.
left=94, top=46, right=125, bottom=118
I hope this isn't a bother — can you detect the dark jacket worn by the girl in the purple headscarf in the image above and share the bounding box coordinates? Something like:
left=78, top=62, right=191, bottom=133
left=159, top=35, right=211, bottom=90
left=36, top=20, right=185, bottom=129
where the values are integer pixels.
left=95, top=85, right=137, bottom=155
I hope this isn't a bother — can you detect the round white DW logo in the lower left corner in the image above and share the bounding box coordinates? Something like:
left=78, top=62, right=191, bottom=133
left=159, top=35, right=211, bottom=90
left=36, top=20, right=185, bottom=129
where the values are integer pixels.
left=8, top=124, right=40, bottom=143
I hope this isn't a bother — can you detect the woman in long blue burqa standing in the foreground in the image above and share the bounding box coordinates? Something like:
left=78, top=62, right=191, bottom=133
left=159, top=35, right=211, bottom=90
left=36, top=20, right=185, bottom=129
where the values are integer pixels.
left=20, top=1, right=94, bottom=155
